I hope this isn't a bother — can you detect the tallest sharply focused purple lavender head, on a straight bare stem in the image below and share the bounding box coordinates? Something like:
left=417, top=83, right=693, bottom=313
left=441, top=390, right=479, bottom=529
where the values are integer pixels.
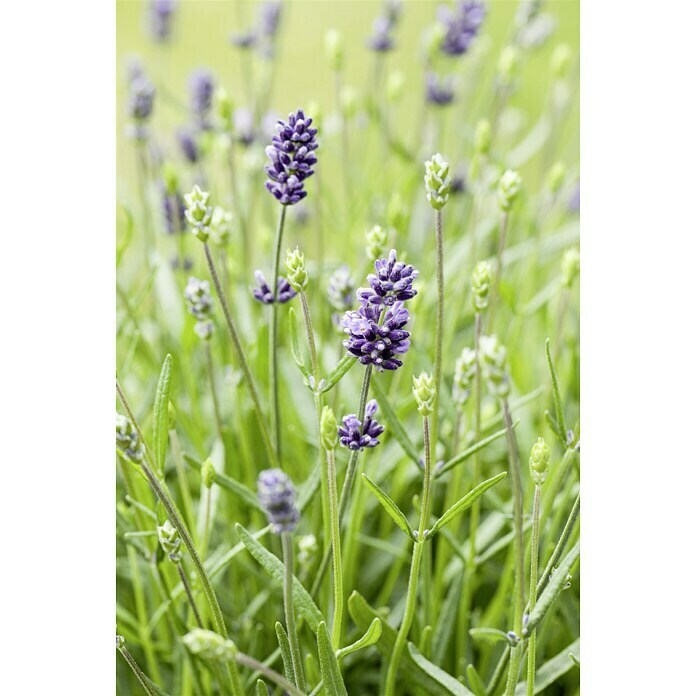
left=266, top=109, right=318, bottom=205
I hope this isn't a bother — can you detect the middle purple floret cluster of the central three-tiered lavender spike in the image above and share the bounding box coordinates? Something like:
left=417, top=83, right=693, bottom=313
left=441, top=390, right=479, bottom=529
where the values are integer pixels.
left=341, top=301, right=411, bottom=372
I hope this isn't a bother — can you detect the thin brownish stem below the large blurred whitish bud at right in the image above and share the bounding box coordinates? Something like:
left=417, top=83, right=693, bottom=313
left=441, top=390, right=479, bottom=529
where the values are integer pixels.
left=502, top=399, right=524, bottom=696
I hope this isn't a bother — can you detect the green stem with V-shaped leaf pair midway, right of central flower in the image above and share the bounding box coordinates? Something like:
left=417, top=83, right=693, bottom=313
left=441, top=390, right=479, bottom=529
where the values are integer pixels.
left=385, top=416, right=431, bottom=696
